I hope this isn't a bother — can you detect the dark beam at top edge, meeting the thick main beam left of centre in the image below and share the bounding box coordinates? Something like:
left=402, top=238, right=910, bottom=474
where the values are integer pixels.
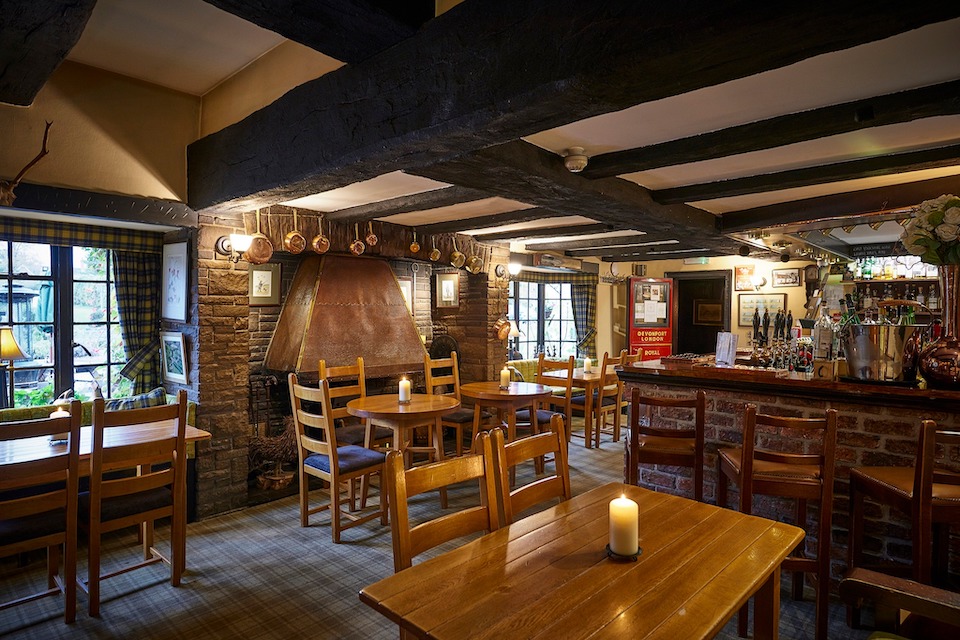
left=204, top=0, right=434, bottom=64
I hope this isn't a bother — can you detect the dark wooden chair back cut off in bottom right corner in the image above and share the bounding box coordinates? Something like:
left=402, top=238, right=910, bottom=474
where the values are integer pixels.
left=840, top=568, right=960, bottom=640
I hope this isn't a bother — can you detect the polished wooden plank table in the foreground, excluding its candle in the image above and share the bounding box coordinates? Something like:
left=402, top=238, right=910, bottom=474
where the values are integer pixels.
left=360, top=483, right=812, bottom=640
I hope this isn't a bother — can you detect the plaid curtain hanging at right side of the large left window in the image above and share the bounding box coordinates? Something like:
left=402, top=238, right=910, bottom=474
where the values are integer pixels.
left=112, top=251, right=160, bottom=394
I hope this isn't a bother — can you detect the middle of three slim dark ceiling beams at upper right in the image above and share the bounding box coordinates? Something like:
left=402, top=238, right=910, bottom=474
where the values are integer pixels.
left=653, top=145, right=960, bottom=204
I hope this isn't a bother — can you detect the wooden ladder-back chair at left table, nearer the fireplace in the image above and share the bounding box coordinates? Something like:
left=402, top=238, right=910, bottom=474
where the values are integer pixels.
left=80, top=389, right=187, bottom=616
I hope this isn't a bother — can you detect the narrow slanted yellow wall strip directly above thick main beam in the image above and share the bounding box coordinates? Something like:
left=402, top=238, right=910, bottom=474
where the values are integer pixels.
left=200, top=40, right=343, bottom=138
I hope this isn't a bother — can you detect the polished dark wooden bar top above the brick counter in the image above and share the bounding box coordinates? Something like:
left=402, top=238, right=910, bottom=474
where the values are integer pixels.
left=617, top=360, right=960, bottom=411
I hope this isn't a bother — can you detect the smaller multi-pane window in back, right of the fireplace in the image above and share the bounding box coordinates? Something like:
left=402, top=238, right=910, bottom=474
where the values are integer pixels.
left=508, top=281, right=578, bottom=359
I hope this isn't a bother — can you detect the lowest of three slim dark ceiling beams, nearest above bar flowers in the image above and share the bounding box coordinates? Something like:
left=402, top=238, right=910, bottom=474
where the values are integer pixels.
left=720, top=175, right=960, bottom=233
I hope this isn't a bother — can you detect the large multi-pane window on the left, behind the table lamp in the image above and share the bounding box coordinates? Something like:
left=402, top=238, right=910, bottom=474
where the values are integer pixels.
left=0, top=241, right=131, bottom=406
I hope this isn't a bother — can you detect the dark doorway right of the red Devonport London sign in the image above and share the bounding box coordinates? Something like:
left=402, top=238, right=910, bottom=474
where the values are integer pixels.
left=664, top=270, right=733, bottom=354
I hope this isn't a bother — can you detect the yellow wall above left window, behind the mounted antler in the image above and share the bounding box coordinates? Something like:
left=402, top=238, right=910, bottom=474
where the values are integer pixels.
left=0, top=61, right=200, bottom=201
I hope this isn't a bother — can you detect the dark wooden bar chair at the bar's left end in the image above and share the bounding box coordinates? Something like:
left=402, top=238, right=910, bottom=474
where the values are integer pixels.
left=626, top=389, right=707, bottom=502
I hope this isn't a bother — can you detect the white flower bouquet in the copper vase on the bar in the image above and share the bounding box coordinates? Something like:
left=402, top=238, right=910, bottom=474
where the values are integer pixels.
left=900, top=195, right=960, bottom=265
